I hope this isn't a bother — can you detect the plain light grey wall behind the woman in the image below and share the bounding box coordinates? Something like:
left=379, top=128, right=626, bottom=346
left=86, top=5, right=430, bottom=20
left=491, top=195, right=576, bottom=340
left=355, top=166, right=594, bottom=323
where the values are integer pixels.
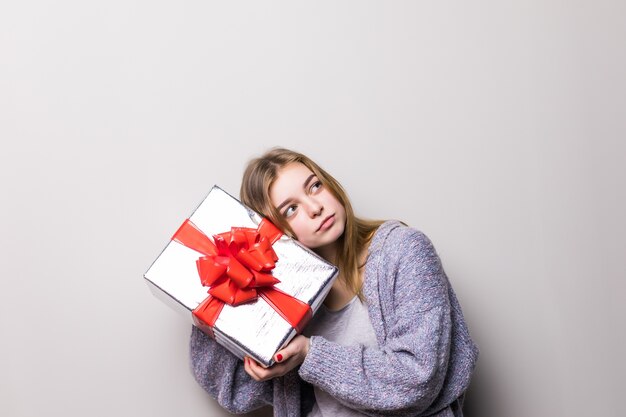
left=0, top=0, right=626, bottom=417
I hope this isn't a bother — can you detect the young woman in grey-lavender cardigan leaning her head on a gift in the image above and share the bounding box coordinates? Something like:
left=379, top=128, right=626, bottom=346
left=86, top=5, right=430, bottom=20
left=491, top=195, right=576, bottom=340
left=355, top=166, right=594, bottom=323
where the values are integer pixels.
left=191, top=149, right=478, bottom=417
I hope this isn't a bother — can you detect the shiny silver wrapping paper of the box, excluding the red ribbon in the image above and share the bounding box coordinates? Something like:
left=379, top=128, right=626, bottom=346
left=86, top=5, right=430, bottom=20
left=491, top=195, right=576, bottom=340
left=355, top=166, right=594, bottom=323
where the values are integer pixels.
left=144, top=186, right=338, bottom=366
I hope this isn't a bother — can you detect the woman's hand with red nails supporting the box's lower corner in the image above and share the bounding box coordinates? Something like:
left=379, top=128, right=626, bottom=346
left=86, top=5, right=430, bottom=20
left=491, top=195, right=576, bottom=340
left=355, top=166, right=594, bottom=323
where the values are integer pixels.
left=243, top=335, right=311, bottom=381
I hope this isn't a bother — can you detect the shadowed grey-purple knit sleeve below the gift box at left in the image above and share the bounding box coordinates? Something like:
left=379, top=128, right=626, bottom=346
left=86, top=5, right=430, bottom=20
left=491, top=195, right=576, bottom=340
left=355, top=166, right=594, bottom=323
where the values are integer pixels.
left=190, top=326, right=272, bottom=414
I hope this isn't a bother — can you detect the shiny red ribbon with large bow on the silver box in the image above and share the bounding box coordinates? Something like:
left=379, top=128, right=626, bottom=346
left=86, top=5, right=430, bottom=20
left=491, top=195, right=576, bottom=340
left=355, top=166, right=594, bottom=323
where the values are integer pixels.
left=172, top=219, right=311, bottom=335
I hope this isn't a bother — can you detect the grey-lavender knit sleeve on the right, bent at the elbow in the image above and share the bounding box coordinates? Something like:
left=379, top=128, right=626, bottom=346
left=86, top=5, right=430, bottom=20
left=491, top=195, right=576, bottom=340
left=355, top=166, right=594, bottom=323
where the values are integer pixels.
left=300, top=227, right=451, bottom=416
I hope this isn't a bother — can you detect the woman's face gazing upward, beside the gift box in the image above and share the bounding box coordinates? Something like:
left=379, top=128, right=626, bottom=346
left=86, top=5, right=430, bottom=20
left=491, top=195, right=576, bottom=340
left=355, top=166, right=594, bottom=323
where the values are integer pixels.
left=269, top=162, right=346, bottom=249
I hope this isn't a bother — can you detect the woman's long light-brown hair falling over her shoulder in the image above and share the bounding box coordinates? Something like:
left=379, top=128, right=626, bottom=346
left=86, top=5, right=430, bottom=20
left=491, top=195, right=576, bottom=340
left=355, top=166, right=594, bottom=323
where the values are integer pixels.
left=240, top=148, right=383, bottom=299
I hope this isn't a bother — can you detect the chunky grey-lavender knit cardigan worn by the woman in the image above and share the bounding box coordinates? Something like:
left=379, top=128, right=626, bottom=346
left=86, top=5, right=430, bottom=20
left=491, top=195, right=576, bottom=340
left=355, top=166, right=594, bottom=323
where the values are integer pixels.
left=190, top=221, right=478, bottom=417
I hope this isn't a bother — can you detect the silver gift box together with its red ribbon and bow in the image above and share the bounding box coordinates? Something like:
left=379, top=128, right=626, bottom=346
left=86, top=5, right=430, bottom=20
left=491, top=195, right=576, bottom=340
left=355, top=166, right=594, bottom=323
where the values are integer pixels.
left=144, top=186, right=338, bottom=366
